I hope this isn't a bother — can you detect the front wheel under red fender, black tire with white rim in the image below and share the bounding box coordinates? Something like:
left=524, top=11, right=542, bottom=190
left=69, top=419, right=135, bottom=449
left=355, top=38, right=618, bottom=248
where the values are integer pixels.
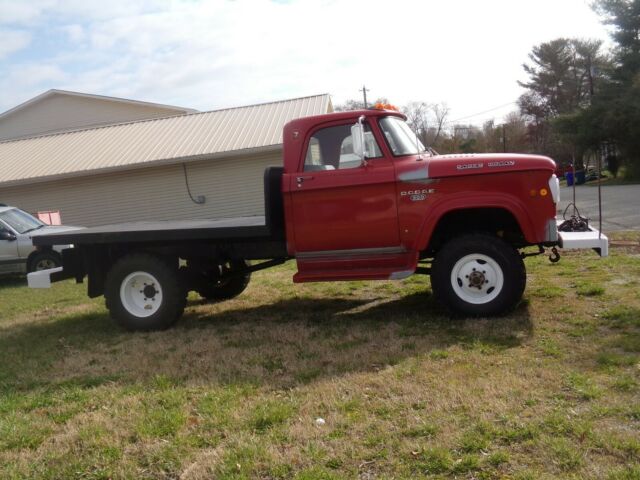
left=431, top=234, right=527, bottom=317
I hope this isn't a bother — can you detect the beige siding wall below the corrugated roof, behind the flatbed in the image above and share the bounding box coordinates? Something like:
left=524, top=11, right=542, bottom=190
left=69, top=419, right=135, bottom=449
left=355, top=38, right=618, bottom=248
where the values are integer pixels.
left=0, top=152, right=282, bottom=226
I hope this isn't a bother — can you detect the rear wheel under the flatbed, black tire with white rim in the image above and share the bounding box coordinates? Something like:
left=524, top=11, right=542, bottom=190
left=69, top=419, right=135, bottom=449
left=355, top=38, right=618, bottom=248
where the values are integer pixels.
left=104, top=253, right=187, bottom=331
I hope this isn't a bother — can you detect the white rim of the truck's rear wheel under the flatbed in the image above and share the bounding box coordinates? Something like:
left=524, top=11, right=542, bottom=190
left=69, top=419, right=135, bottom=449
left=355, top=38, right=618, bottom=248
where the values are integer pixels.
left=120, top=272, right=162, bottom=317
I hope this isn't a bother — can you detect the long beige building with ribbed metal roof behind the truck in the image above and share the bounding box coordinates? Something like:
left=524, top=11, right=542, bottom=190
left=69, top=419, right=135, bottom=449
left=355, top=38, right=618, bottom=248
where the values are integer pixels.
left=0, top=91, right=333, bottom=226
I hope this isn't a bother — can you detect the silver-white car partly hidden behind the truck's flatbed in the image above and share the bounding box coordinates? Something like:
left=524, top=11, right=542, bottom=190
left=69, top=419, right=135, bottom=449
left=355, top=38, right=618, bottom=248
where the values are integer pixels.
left=0, top=206, right=81, bottom=273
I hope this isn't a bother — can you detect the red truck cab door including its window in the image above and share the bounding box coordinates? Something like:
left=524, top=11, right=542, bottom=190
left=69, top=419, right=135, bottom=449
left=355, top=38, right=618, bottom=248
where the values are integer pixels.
left=289, top=120, right=400, bottom=251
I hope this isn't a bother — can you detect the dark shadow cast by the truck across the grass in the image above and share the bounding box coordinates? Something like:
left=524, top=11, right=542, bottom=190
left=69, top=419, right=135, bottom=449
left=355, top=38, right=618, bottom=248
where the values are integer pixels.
left=0, top=292, right=532, bottom=392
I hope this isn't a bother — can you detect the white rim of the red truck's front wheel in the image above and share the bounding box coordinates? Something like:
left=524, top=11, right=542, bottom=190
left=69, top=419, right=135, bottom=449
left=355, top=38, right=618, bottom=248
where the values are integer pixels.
left=451, top=253, right=504, bottom=305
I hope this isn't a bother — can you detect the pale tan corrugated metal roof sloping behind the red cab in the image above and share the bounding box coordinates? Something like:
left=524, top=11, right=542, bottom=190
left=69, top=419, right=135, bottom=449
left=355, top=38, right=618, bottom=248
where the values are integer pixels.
left=0, top=94, right=331, bottom=186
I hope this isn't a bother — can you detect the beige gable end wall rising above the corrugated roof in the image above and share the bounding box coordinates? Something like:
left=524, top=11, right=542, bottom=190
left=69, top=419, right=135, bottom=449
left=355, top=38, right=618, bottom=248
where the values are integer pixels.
left=0, top=94, right=191, bottom=141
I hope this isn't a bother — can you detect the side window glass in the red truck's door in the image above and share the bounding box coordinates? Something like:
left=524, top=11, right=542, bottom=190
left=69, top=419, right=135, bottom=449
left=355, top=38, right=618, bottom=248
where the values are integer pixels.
left=304, top=124, right=382, bottom=172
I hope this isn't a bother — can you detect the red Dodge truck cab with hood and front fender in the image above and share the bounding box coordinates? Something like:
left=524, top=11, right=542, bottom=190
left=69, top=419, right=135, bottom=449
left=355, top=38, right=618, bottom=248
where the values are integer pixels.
left=282, top=110, right=559, bottom=292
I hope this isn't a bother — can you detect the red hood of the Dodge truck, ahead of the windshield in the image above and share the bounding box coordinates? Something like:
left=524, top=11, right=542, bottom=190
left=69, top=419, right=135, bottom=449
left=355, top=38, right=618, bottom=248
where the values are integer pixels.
left=428, top=153, right=556, bottom=178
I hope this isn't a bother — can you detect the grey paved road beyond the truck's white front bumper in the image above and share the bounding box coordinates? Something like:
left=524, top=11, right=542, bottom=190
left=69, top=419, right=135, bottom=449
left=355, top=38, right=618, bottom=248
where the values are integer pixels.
left=558, top=185, right=640, bottom=232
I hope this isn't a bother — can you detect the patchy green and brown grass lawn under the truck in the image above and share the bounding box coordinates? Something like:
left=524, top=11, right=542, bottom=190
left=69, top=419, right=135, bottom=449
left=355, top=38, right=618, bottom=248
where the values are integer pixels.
left=0, top=232, right=640, bottom=480
